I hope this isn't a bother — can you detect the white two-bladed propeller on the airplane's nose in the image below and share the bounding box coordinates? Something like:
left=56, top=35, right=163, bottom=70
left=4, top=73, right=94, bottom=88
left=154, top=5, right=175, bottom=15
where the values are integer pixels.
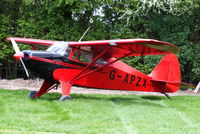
left=10, top=38, right=29, bottom=77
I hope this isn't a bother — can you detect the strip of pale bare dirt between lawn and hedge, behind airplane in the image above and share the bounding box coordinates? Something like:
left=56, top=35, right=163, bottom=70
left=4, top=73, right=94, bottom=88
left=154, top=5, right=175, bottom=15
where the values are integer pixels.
left=0, top=79, right=200, bottom=96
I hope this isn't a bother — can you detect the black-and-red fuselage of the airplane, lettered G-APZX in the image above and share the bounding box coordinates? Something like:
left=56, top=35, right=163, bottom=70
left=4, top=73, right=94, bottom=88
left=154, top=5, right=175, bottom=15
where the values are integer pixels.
left=23, top=48, right=178, bottom=92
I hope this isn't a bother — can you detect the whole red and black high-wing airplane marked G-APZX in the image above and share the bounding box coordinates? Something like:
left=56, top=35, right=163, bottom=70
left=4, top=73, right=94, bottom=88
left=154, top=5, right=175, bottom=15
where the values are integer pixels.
left=7, top=37, right=191, bottom=101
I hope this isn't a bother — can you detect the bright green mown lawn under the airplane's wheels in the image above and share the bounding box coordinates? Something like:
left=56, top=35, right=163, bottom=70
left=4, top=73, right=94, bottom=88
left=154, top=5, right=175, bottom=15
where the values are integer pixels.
left=0, top=89, right=200, bottom=134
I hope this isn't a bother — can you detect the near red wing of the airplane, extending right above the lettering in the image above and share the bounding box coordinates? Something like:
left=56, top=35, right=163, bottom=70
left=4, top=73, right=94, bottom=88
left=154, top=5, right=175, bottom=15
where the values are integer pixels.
left=69, top=39, right=178, bottom=57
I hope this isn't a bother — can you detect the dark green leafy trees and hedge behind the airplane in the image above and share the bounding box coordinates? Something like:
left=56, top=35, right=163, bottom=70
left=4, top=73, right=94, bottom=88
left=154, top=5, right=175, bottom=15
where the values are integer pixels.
left=0, top=0, right=200, bottom=83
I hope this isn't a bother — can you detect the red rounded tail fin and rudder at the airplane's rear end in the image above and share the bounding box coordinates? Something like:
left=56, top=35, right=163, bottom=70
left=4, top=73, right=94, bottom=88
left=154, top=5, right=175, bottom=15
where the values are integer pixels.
left=149, top=54, right=182, bottom=93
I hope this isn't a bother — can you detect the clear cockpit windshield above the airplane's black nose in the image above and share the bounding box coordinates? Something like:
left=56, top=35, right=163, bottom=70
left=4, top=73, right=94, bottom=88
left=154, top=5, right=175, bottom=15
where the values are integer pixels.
left=46, top=42, right=70, bottom=54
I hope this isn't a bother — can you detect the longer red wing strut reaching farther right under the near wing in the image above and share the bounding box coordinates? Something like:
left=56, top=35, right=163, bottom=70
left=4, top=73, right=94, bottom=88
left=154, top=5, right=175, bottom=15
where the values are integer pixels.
left=71, top=51, right=133, bottom=82
